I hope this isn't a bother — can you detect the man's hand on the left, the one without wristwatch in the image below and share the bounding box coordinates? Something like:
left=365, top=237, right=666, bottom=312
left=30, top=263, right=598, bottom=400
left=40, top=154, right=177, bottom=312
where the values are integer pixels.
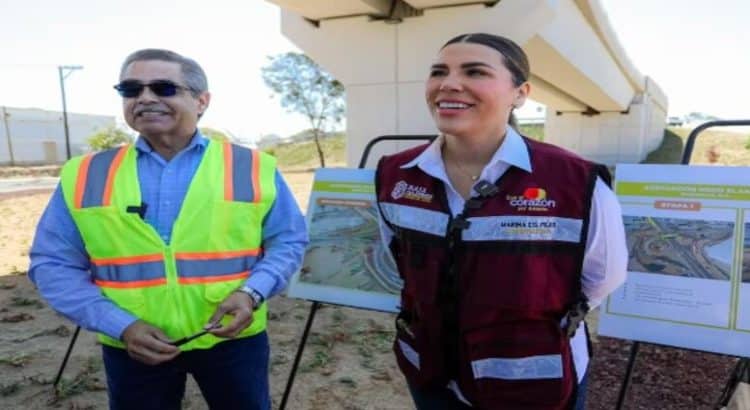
left=122, top=320, right=180, bottom=365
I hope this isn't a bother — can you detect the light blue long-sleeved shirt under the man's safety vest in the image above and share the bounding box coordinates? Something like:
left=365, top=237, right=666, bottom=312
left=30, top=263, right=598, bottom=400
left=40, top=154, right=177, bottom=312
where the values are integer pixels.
left=29, top=133, right=307, bottom=339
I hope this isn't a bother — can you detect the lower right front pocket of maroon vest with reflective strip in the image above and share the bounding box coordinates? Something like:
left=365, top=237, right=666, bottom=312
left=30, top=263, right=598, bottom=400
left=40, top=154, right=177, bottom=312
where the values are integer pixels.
left=464, top=322, right=574, bottom=409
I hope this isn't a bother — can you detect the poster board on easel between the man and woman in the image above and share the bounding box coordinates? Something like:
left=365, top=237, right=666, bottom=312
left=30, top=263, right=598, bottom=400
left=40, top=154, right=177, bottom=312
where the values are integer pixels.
left=287, top=168, right=403, bottom=312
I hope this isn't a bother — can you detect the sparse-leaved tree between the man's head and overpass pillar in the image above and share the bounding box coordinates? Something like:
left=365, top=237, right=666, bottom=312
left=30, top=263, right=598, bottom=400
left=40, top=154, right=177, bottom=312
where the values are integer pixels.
left=262, top=52, right=344, bottom=167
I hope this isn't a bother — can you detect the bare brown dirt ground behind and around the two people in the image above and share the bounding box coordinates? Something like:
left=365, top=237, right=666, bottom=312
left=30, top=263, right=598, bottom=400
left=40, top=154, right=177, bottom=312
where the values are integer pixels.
left=0, top=166, right=735, bottom=410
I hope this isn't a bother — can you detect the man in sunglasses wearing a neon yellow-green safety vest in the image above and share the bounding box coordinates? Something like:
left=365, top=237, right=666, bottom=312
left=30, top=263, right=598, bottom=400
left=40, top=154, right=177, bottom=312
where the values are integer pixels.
left=29, top=49, right=307, bottom=410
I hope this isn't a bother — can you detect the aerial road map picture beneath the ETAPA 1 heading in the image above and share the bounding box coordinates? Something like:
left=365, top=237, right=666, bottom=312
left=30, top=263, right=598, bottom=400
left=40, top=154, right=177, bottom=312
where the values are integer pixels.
left=623, top=216, right=736, bottom=280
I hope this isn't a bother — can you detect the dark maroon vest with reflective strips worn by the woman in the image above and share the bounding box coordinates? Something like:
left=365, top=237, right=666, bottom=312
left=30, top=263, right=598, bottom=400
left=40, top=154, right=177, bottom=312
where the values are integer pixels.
left=376, top=138, right=609, bottom=410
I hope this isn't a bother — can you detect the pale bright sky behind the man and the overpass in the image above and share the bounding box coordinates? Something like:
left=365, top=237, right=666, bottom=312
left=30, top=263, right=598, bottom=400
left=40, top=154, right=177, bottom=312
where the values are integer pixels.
left=0, top=0, right=750, bottom=140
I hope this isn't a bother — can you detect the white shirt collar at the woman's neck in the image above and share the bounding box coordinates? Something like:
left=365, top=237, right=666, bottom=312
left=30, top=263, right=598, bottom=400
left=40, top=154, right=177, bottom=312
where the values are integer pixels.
left=401, top=125, right=531, bottom=172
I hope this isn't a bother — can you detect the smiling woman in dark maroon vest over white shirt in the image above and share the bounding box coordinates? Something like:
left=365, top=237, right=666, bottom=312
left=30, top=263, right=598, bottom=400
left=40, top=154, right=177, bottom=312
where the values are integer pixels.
left=376, top=33, right=627, bottom=410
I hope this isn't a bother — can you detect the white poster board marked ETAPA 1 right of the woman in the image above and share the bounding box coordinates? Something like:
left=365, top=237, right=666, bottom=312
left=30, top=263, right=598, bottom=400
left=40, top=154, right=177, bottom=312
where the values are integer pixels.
left=599, top=164, right=750, bottom=357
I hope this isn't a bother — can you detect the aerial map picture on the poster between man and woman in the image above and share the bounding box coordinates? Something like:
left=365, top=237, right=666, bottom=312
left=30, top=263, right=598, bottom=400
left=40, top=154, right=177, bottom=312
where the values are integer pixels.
left=299, top=197, right=402, bottom=295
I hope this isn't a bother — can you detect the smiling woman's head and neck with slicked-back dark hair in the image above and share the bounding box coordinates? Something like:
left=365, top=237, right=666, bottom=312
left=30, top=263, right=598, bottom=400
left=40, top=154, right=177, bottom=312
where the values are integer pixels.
left=426, top=35, right=530, bottom=198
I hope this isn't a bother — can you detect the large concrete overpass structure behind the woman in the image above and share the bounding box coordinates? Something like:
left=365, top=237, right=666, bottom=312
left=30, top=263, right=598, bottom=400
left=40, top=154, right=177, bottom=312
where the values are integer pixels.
left=268, top=0, right=667, bottom=165
